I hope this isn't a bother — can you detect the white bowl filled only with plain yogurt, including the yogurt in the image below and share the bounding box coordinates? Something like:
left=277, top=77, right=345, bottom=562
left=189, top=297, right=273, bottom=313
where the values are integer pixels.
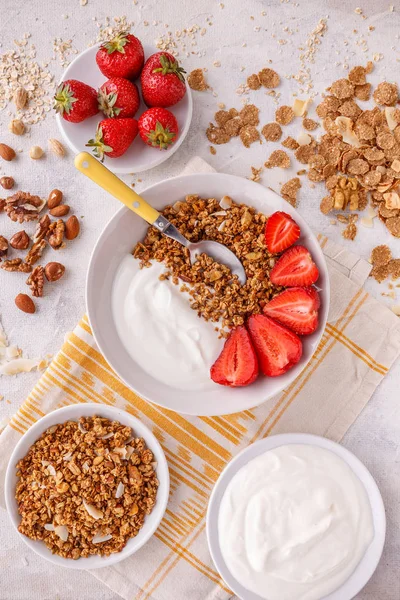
left=207, top=434, right=386, bottom=600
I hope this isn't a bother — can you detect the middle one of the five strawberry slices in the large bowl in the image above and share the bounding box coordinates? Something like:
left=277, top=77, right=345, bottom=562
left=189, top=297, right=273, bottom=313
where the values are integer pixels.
left=264, top=287, right=320, bottom=335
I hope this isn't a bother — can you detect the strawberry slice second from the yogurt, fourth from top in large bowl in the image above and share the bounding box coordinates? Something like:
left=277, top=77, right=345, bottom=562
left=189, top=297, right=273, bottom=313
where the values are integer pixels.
left=247, top=315, right=303, bottom=377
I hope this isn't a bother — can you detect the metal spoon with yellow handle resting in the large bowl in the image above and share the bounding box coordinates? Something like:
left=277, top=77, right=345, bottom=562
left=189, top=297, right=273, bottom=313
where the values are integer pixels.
left=75, top=152, right=246, bottom=285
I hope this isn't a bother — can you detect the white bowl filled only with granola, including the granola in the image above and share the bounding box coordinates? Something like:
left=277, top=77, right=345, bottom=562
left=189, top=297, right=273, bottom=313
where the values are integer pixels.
left=5, top=404, right=169, bottom=569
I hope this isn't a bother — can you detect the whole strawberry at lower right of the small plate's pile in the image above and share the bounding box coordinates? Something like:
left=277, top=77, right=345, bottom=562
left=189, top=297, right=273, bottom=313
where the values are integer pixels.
left=138, top=107, right=178, bottom=150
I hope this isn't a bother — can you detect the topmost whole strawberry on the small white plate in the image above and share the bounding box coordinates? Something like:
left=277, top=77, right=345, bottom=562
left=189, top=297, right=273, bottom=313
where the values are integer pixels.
left=96, top=32, right=144, bottom=79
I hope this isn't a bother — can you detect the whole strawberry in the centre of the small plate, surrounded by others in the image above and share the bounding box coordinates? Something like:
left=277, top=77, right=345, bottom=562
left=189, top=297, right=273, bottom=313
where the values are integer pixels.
left=98, top=77, right=140, bottom=119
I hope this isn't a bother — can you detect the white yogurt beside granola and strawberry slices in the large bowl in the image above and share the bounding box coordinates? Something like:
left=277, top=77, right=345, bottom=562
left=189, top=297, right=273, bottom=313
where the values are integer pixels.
left=112, top=255, right=223, bottom=390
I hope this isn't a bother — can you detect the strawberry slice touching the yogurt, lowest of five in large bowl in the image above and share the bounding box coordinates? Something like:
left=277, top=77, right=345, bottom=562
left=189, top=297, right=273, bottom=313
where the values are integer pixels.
left=210, top=325, right=258, bottom=387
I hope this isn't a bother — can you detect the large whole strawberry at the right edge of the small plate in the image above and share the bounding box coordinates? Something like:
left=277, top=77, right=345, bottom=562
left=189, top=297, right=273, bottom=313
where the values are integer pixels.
left=140, top=52, right=186, bottom=107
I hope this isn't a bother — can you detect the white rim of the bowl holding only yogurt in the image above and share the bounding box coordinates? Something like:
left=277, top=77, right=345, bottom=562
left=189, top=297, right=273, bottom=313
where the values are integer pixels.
left=206, top=433, right=386, bottom=600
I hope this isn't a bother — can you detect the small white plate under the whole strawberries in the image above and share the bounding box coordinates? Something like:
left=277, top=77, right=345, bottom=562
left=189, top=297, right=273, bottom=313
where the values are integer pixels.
left=56, top=44, right=193, bottom=173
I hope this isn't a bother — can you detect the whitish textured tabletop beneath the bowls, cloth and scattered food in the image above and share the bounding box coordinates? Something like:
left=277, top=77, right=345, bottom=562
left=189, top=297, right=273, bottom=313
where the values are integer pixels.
left=0, top=0, right=400, bottom=600
